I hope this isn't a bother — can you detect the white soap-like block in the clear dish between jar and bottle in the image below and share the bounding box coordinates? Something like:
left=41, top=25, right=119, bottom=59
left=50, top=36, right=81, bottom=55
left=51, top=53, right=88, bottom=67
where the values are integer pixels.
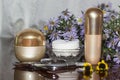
left=52, top=39, right=79, bottom=57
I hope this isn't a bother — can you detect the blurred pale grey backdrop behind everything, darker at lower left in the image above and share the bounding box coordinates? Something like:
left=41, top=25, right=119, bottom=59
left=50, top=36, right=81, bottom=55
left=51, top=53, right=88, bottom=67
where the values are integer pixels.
left=0, top=0, right=120, bottom=80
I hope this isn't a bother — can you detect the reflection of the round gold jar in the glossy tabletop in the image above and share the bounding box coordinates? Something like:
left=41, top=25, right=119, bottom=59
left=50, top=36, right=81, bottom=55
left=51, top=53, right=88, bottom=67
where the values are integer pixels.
left=14, top=70, right=45, bottom=80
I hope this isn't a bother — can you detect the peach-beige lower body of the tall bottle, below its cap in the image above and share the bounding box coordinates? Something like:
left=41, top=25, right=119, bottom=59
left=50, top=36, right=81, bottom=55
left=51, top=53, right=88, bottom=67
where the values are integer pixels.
left=85, top=35, right=102, bottom=64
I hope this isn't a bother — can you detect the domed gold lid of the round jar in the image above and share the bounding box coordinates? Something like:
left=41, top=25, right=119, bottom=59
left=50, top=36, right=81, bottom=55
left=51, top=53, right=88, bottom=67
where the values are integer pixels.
left=15, top=28, right=45, bottom=47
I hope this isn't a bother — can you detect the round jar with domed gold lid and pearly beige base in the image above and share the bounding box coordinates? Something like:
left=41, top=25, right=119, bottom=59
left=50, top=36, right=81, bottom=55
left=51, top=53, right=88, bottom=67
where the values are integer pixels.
left=15, top=28, right=45, bottom=62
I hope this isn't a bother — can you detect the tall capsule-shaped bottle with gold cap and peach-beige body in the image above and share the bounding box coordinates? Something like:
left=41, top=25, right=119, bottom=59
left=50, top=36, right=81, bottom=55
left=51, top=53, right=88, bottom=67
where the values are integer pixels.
left=85, top=8, right=103, bottom=64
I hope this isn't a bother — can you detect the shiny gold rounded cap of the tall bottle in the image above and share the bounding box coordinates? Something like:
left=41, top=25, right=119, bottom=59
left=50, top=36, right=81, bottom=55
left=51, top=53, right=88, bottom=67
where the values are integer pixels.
left=85, top=8, right=103, bottom=34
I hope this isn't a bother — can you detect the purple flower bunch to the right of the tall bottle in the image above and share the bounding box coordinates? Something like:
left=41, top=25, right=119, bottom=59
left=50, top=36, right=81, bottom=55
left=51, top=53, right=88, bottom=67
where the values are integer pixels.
left=97, top=3, right=120, bottom=64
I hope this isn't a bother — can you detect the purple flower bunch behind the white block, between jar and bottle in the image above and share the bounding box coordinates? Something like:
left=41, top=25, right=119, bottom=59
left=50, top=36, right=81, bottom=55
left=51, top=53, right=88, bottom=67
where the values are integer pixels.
left=44, top=9, right=83, bottom=41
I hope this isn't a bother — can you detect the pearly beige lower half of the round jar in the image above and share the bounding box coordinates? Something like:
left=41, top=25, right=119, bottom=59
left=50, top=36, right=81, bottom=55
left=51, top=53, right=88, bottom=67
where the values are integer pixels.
left=15, top=46, right=45, bottom=62
